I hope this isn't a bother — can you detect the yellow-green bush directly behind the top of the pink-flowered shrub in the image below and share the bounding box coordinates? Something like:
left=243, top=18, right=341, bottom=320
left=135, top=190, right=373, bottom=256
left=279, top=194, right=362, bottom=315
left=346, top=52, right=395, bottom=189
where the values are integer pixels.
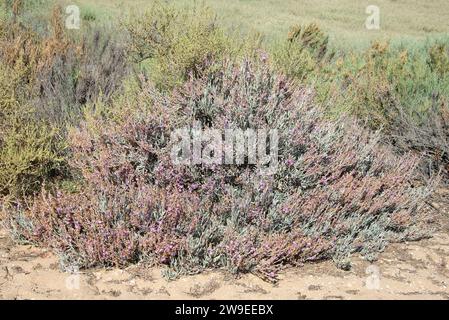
left=124, top=2, right=258, bottom=90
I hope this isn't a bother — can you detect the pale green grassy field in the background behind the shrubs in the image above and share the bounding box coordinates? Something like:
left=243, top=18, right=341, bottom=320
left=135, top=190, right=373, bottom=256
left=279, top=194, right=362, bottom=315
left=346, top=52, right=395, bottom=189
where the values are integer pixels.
left=58, top=0, right=449, bottom=47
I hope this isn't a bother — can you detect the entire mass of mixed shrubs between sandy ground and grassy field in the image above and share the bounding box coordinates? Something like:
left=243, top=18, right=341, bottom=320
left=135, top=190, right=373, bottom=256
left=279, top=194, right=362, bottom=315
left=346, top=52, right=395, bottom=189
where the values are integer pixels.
left=0, top=0, right=449, bottom=281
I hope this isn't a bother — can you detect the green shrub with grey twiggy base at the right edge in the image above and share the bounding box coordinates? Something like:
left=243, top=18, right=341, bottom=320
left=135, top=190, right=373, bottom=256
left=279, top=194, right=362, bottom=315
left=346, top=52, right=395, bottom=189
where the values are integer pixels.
left=326, top=43, right=449, bottom=175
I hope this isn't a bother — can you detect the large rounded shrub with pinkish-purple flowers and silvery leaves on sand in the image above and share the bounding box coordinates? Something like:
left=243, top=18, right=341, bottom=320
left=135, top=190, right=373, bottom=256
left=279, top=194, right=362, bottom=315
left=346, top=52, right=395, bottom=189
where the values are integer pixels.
left=9, top=62, right=429, bottom=281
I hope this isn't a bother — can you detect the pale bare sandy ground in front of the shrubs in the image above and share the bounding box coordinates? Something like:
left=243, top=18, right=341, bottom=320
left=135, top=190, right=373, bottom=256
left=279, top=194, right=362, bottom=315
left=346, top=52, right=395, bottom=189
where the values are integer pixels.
left=0, top=225, right=449, bottom=299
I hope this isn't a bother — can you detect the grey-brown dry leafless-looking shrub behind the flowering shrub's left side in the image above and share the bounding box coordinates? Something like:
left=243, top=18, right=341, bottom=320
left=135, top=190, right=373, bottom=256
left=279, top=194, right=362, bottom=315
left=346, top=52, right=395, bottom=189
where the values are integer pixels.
left=35, top=29, right=129, bottom=126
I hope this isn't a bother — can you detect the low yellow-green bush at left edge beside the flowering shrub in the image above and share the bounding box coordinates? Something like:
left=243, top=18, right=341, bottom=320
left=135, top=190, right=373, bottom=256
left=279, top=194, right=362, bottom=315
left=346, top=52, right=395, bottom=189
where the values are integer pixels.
left=0, top=64, right=64, bottom=197
